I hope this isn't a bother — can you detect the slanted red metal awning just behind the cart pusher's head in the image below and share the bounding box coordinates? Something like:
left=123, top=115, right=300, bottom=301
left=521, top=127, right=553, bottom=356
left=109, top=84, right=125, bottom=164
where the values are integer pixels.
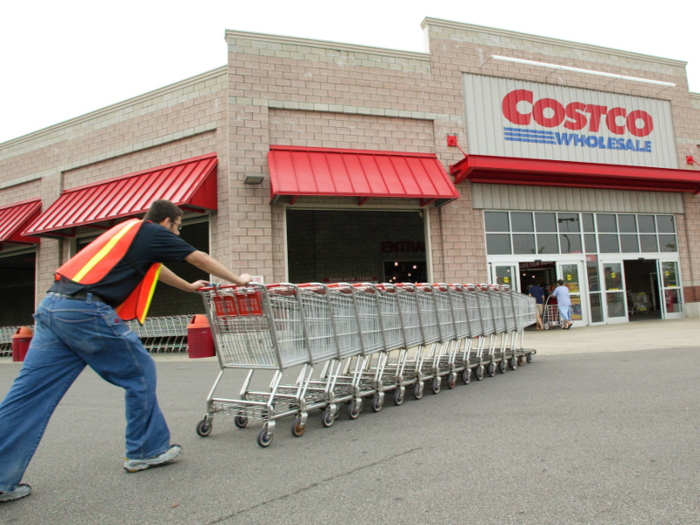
left=24, top=153, right=217, bottom=237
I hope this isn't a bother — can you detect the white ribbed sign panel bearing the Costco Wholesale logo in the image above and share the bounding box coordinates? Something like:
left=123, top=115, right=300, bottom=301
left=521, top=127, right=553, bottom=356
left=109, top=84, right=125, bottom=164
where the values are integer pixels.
left=464, top=74, right=678, bottom=168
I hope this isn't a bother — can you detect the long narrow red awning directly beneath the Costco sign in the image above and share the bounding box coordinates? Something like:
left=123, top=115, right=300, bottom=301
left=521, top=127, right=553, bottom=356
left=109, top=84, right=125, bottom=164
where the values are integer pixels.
left=450, top=155, right=700, bottom=193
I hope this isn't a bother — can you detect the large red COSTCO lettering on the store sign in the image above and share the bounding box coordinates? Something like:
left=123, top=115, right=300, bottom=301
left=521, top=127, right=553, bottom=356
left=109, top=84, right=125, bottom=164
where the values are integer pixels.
left=501, top=89, right=654, bottom=137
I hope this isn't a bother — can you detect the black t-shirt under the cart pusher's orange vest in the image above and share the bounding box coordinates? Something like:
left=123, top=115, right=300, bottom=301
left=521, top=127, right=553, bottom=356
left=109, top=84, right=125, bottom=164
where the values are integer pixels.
left=49, top=221, right=196, bottom=307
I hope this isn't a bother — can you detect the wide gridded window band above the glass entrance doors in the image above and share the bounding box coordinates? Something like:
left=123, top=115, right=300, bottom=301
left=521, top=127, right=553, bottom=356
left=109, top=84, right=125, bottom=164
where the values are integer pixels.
left=484, top=211, right=678, bottom=255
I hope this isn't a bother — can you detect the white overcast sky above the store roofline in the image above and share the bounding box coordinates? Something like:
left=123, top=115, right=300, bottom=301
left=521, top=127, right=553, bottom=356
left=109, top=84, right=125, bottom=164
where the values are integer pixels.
left=0, top=0, right=700, bottom=143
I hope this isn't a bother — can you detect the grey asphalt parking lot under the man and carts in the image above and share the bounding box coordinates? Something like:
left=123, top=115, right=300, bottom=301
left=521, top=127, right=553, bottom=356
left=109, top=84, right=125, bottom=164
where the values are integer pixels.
left=0, top=348, right=700, bottom=525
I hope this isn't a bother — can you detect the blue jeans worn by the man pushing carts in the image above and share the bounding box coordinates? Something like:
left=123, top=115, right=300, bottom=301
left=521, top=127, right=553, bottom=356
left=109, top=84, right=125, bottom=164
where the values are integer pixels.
left=0, top=292, right=170, bottom=491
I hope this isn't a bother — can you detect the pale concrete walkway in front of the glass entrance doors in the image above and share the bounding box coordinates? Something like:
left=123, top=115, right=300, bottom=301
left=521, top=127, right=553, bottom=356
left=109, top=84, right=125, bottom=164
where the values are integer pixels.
left=525, top=318, right=700, bottom=355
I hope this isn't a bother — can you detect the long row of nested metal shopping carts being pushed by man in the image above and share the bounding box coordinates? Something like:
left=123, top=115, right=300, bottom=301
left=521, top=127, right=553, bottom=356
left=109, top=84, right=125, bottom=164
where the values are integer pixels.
left=197, top=283, right=536, bottom=447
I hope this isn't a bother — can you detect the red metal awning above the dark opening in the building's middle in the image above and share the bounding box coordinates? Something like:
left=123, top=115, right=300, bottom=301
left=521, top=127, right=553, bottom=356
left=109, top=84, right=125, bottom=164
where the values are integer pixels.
left=267, top=146, right=459, bottom=206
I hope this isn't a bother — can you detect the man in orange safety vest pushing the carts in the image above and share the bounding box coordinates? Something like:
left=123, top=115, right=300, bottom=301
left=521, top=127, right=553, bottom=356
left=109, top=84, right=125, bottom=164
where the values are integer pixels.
left=0, top=200, right=251, bottom=502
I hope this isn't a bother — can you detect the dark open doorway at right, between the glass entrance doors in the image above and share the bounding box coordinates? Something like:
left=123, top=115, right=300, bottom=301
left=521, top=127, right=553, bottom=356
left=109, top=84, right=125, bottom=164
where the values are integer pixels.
left=624, top=259, right=663, bottom=321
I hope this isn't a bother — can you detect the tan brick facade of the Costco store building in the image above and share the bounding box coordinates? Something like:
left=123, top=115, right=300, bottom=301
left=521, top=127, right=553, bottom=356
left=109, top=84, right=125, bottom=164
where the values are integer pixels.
left=0, top=19, right=700, bottom=324
